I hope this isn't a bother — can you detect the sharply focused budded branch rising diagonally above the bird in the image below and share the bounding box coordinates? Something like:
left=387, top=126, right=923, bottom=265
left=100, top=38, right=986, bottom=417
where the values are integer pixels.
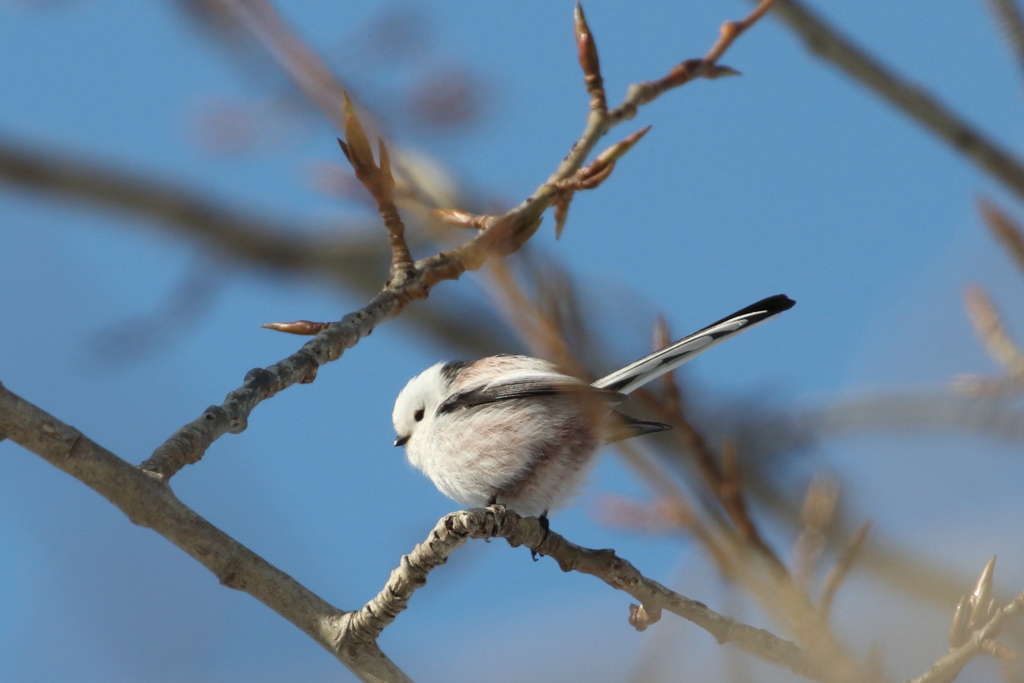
left=141, top=0, right=773, bottom=480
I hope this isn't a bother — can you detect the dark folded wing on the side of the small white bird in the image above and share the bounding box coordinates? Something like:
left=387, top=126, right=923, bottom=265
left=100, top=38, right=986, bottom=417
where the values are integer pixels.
left=437, top=372, right=627, bottom=415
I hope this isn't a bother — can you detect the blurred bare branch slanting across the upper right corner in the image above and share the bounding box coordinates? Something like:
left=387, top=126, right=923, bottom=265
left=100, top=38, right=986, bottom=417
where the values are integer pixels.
left=761, top=0, right=1024, bottom=198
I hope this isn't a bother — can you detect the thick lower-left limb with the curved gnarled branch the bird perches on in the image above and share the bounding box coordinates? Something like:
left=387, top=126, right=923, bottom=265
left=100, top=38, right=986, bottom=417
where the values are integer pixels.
left=0, top=385, right=829, bottom=682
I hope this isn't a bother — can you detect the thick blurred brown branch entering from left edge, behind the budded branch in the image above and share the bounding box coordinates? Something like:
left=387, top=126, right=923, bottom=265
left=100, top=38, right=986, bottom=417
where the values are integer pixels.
left=0, top=135, right=507, bottom=355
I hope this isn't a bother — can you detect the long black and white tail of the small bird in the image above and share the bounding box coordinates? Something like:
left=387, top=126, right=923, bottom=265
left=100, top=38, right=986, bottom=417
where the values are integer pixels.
left=593, top=294, right=797, bottom=393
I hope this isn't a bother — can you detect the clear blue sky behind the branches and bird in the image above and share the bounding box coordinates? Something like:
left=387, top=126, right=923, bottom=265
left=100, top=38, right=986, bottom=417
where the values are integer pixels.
left=0, top=0, right=1024, bottom=683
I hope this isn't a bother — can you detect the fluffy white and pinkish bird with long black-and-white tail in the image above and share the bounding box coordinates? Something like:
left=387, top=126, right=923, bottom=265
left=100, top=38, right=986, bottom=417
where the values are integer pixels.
left=391, top=294, right=796, bottom=524
